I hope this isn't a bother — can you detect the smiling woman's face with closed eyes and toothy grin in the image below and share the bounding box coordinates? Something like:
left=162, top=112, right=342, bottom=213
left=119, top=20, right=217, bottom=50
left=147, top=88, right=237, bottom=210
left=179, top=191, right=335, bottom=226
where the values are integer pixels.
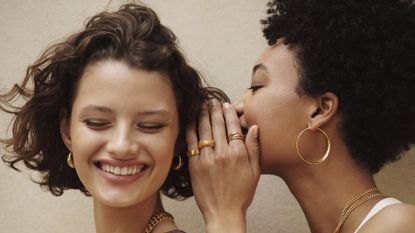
left=61, top=61, right=178, bottom=207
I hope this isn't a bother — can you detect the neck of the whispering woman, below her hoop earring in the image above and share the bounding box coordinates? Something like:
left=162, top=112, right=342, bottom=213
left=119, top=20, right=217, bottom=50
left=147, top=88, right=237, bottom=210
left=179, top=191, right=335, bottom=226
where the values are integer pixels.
left=275, top=147, right=378, bottom=233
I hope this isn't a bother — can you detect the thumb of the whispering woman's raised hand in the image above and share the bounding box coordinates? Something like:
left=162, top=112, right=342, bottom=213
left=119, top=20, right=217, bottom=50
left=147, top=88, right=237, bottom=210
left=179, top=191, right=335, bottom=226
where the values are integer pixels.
left=245, top=125, right=261, bottom=178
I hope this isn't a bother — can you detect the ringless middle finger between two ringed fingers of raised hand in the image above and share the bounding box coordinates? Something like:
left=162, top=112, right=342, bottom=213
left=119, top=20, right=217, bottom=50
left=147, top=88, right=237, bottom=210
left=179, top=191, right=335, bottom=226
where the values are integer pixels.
left=209, top=99, right=228, bottom=151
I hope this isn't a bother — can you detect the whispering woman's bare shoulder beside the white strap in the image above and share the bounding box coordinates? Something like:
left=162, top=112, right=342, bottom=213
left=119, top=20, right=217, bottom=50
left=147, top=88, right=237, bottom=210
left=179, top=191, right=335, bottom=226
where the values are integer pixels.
left=359, top=203, right=415, bottom=233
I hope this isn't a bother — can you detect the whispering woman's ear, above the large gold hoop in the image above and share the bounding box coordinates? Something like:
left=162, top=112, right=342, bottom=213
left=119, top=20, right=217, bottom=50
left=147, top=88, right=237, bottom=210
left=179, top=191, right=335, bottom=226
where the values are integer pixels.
left=308, top=92, right=339, bottom=130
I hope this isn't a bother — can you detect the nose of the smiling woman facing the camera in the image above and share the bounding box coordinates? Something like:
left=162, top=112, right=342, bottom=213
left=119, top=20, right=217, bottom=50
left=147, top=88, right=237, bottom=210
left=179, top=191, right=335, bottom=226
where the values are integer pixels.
left=107, top=127, right=138, bottom=157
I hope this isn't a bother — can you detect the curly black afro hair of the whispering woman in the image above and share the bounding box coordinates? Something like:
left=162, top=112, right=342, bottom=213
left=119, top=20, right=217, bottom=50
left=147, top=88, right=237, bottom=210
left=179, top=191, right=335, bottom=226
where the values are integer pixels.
left=261, top=0, right=415, bottom=173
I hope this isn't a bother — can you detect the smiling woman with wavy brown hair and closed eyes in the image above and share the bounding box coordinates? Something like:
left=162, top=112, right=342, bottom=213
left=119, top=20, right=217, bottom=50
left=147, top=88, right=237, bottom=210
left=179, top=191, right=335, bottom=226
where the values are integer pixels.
left=0, top=4, right=226, bottom=233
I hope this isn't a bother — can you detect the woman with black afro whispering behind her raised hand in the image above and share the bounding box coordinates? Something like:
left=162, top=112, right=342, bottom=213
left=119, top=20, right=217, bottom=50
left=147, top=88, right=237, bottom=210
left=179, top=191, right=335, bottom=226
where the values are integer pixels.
left=187, top=0, right=415, bottom=233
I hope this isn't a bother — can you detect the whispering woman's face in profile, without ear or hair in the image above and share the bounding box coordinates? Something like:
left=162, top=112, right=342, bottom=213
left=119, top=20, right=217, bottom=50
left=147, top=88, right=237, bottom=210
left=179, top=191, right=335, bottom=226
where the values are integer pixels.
left=235, top=43, right=311, bottom=173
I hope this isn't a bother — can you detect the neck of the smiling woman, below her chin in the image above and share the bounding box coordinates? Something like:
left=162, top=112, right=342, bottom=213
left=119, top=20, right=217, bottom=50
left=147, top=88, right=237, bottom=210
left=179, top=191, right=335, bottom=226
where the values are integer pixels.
left=94, top=194, right=163, bottom=233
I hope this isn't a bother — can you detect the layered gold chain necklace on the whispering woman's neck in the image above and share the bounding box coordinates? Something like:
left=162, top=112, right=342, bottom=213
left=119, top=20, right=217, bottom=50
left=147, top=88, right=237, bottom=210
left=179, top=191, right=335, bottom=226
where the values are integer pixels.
left=334, top=188, right=383, bottom=233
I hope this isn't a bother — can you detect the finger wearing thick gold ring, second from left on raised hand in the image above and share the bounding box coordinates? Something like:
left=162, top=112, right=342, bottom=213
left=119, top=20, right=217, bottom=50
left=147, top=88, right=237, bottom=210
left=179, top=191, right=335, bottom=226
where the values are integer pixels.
left=199, top=103, right=213, bottom=155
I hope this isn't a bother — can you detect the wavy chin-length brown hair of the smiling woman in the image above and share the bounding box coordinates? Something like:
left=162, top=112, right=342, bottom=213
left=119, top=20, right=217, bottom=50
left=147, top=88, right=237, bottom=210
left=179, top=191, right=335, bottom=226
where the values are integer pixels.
left=0, top=3, right=228, bottom=199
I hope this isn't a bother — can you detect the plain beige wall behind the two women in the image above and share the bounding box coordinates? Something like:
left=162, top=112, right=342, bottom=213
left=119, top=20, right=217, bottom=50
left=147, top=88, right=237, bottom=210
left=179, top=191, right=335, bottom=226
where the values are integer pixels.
left=0, top=0, right=415, bottom=233
